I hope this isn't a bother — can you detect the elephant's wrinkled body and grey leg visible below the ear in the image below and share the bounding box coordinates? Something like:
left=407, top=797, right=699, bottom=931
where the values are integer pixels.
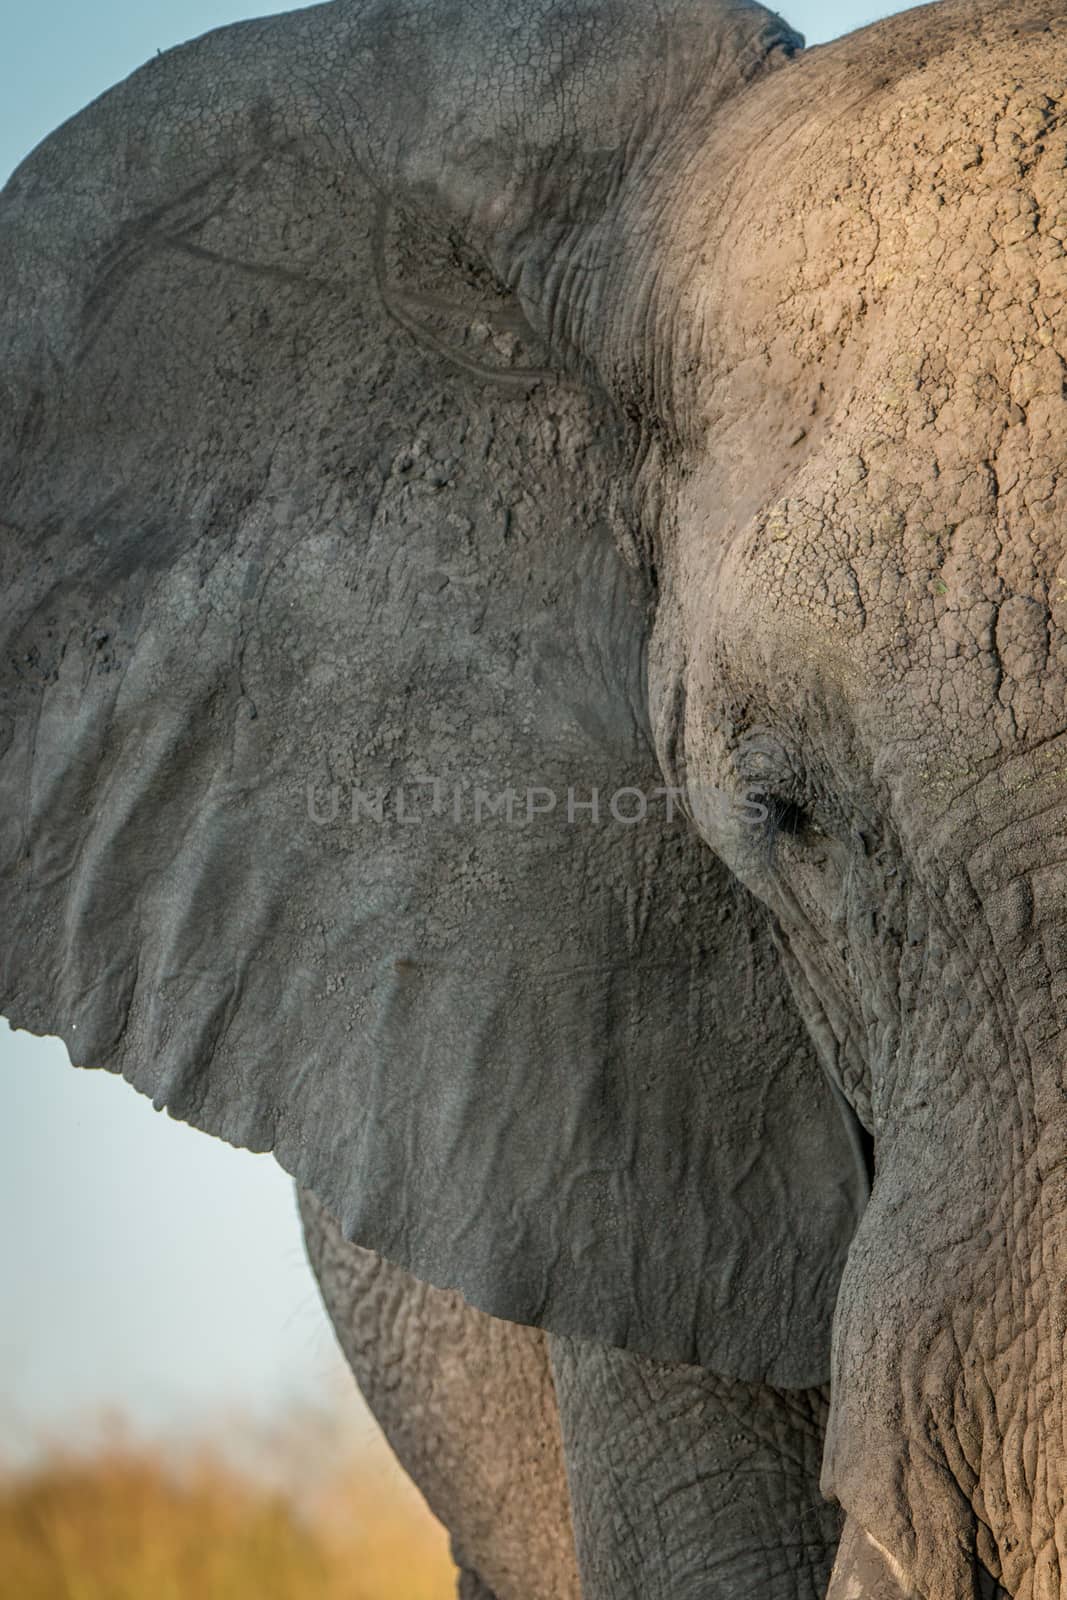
left=301, top=1192, right=840, bottom=1600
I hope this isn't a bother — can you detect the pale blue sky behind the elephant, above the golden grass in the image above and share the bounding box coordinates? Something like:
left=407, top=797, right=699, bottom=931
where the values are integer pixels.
left=0, top=0, right=902, bottom=1456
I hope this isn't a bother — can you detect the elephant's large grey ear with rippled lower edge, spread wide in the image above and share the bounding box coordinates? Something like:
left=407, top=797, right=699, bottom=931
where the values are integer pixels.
left=0, top=0, right=865, bottom=1386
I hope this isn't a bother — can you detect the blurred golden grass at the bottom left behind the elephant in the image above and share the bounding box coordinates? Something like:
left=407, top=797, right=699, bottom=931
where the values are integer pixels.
left=0, top=1427, right=456, bottom=1600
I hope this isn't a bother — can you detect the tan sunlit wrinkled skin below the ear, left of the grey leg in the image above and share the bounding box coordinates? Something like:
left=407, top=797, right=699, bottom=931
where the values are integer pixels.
left=301, top=1192, right=585, bottom=1600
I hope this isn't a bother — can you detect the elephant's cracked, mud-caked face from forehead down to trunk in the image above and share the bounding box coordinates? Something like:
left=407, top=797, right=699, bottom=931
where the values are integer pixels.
left=653, top=5, right=1067, bottom=1600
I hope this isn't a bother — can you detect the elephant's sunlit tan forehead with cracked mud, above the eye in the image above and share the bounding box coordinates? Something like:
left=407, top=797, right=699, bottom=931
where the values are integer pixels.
left=680, top=5, right=1067, bottom=757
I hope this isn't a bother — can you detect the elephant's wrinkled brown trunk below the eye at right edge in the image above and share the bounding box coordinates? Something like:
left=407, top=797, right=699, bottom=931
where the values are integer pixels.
left=824, top=796, right=1067, bottom=1600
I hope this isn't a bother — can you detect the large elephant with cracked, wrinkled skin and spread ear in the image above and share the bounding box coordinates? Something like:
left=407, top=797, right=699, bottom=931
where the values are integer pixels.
left=0, top=0, right=1067, bottom=1600
